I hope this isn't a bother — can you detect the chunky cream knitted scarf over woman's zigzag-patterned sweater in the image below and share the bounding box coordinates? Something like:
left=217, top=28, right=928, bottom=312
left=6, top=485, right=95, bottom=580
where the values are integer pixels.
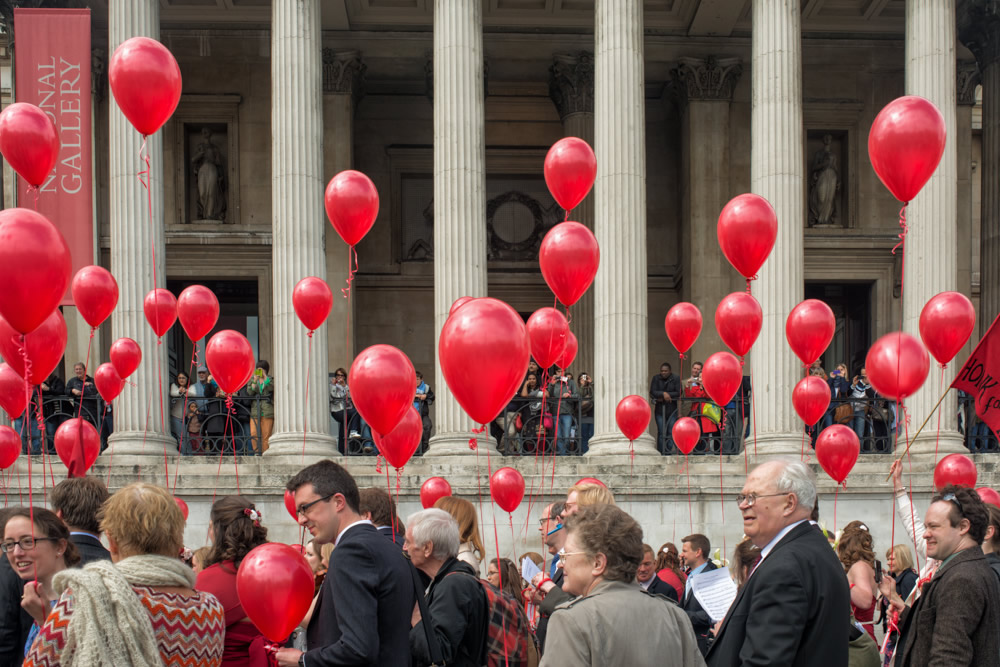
left=52, top=555, right=195, bottom=667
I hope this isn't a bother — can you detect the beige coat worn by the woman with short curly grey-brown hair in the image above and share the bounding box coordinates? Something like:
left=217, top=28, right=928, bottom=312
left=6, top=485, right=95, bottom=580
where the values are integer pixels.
left=541, top=581, right=705, bottom=667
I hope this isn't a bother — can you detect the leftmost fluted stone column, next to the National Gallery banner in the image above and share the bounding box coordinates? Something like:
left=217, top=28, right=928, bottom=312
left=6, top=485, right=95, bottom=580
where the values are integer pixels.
left=104, top=0, right=177, bottom=463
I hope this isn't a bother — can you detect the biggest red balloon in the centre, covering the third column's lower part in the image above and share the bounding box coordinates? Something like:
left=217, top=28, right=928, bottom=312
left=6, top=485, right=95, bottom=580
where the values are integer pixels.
left=440, top=298, right=530, bottom=424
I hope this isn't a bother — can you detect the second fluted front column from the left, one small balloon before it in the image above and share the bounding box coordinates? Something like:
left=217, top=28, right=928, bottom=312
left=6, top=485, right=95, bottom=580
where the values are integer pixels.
left=268, top=0, right=337, bottom=456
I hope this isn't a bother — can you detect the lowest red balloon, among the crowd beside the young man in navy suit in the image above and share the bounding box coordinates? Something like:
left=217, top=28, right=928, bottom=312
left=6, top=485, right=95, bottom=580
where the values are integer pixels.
left=236, top=542, right=314, bottom=644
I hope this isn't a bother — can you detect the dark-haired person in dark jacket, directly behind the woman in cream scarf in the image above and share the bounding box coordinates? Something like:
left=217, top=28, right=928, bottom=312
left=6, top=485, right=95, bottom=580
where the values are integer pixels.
left=52, top=477, right=111, bottom=567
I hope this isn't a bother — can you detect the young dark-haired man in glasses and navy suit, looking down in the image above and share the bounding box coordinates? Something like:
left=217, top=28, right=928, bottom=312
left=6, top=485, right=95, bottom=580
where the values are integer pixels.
left=277, top=460, right=416, bottom=667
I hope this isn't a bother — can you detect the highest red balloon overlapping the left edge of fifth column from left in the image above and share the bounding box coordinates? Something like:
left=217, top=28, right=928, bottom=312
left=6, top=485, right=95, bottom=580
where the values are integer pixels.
left=716, top=194, right=778, bottom=279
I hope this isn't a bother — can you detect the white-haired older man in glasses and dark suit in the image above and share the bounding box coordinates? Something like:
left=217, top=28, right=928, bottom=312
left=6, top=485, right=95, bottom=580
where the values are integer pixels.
left=706, top=459, right=851, bottom=667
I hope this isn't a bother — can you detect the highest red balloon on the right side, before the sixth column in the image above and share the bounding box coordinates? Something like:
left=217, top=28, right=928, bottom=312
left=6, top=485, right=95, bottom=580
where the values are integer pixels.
left=868, top=95, right=947, bottom=202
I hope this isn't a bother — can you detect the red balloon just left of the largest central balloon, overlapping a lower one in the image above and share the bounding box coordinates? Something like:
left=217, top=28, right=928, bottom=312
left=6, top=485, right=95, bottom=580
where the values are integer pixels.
left=347, top=345, right=417, bottom=435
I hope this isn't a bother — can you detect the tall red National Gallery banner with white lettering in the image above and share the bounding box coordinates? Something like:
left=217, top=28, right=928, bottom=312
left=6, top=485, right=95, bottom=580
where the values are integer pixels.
left=14, top=9, right=94, bottom=305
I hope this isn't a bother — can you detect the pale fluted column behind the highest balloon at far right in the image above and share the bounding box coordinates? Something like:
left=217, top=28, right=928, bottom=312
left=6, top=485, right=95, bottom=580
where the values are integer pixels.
left=903, top=0, right=964, bottom=456
